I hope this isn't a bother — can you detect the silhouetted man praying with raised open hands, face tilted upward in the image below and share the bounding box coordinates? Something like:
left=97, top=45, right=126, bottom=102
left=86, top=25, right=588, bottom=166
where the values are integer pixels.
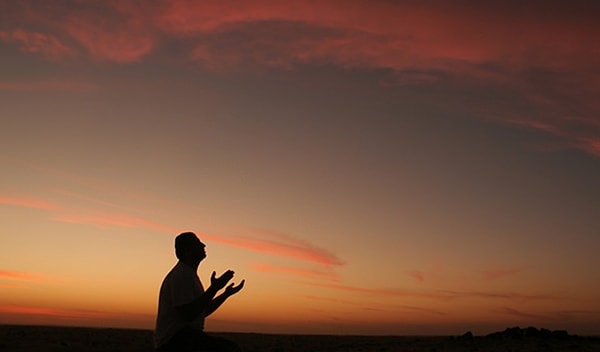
left=154, top=232, right=245, bottom=352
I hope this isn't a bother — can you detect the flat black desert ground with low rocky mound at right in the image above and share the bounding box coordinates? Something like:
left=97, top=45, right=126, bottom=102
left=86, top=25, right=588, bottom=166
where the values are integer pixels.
left=0, top=325, right=600, bottom=352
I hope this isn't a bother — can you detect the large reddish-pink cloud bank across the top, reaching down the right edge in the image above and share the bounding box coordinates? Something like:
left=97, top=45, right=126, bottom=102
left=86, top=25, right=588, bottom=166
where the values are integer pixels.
left=0, top=0, right=600, bottom=156
